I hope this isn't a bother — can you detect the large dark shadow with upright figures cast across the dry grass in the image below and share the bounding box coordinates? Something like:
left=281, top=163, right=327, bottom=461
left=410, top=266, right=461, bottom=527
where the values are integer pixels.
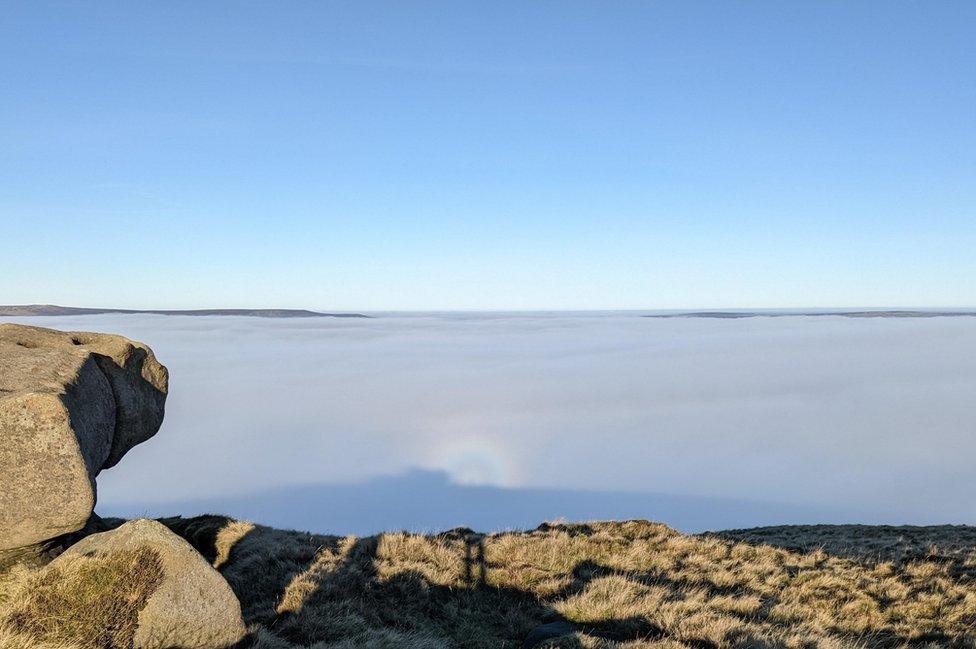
left=161, top=515, right=659, bottom=649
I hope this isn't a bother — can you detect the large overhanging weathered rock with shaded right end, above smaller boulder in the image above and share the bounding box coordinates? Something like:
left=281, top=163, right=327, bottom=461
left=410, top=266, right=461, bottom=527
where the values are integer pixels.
left=0, top=324, right=168, bottom=552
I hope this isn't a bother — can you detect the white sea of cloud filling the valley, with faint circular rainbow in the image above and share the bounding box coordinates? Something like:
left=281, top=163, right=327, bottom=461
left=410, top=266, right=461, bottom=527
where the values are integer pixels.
left=11, top=313, right=976, bottom=532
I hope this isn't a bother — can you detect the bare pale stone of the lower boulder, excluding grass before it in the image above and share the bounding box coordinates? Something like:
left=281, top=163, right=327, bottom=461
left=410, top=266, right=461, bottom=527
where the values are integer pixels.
left=50, top=520, right=245, bottom=649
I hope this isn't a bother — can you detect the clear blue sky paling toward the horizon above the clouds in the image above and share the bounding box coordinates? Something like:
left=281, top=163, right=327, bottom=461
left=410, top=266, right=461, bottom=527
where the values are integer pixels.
left=0, top=0, right=976, bottom=310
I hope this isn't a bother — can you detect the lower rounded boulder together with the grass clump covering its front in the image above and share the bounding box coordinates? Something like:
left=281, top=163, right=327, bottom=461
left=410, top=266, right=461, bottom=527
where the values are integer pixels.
left=7, top=520, right=245, bottom=649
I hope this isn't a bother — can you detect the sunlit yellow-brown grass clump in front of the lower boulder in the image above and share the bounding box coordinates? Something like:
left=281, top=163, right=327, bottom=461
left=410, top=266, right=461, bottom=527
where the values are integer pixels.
left=0, top=548, right=163, bottom=649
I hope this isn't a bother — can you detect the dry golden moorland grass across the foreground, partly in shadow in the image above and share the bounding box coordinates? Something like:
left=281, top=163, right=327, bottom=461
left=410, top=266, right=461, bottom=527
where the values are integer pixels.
left=0, top=516, right=976, bottom=649
